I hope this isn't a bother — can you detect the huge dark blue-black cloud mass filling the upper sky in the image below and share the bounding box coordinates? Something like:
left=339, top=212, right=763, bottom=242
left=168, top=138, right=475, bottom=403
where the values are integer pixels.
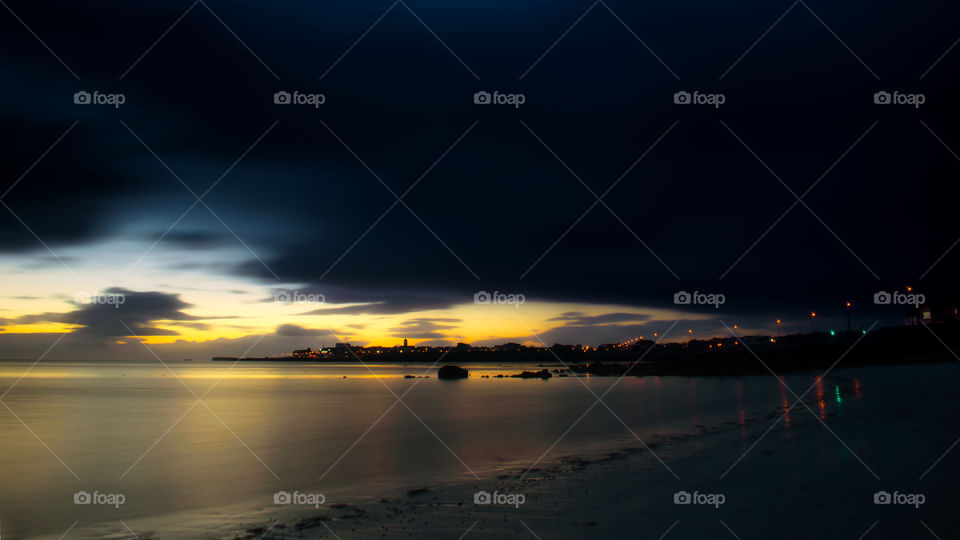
left=0, top=0, right=960, bottom=338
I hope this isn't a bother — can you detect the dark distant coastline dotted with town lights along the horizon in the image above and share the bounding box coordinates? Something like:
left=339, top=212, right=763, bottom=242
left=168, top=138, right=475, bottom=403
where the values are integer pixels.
left=213, top=323, right=960, bottom=376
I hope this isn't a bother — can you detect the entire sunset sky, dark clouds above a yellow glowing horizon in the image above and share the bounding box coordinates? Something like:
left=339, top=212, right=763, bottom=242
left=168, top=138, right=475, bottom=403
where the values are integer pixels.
left=0, top=0, right=960, bottom=359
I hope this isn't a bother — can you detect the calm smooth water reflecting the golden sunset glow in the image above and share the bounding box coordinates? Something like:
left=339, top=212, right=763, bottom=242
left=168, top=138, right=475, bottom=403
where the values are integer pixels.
left=0, top=361, right=877, bottom=538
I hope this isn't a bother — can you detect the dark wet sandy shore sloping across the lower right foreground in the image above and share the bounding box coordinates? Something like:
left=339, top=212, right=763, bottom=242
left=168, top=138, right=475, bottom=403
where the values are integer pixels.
left=219, top=368, right=960, bottom=539
